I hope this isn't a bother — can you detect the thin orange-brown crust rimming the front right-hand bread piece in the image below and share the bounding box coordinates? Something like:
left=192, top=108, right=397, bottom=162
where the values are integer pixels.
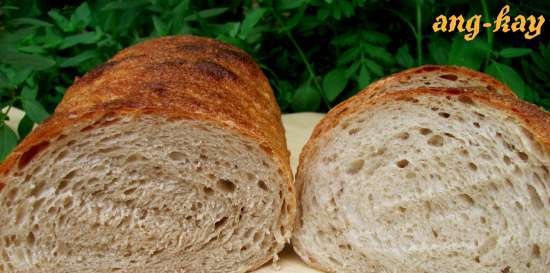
left=293, top=88, right=550, bottom=272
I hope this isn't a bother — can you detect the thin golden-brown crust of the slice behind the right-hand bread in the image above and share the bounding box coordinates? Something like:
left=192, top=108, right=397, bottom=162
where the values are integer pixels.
left=361, top=64, right=516, bottom=97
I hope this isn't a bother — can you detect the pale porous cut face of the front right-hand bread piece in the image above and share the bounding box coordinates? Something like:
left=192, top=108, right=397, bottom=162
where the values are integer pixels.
left=293, top=95, right=550, bottom=273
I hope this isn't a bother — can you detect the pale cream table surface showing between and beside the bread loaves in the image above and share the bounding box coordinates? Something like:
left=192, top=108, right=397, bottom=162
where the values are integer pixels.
left=3, top=108, right=323, bottom=273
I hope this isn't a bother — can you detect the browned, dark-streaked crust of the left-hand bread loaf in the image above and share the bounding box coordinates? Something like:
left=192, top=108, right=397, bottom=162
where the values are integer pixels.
left=0, top=36, right=296, bottom=267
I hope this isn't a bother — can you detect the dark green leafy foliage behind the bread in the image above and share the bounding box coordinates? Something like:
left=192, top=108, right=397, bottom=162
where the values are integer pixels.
left=0, top=0, right=550, bottom=160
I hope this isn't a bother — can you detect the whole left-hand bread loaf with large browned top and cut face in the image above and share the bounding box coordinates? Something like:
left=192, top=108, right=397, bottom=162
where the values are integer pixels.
left=0, top=36, right=296, bottom=273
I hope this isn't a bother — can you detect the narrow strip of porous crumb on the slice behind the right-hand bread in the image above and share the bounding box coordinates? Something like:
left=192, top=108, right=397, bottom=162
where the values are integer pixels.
left=371, top=70, right=508, bottom=98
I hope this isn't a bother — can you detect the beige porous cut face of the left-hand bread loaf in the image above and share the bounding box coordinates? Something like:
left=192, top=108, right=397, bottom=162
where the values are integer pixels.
left=0, top=117, right=290, bottom=273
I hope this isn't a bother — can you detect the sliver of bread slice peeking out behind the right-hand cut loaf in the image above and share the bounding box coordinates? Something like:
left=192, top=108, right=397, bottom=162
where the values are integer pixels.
left=362, top=65, right=516, bottom=97
